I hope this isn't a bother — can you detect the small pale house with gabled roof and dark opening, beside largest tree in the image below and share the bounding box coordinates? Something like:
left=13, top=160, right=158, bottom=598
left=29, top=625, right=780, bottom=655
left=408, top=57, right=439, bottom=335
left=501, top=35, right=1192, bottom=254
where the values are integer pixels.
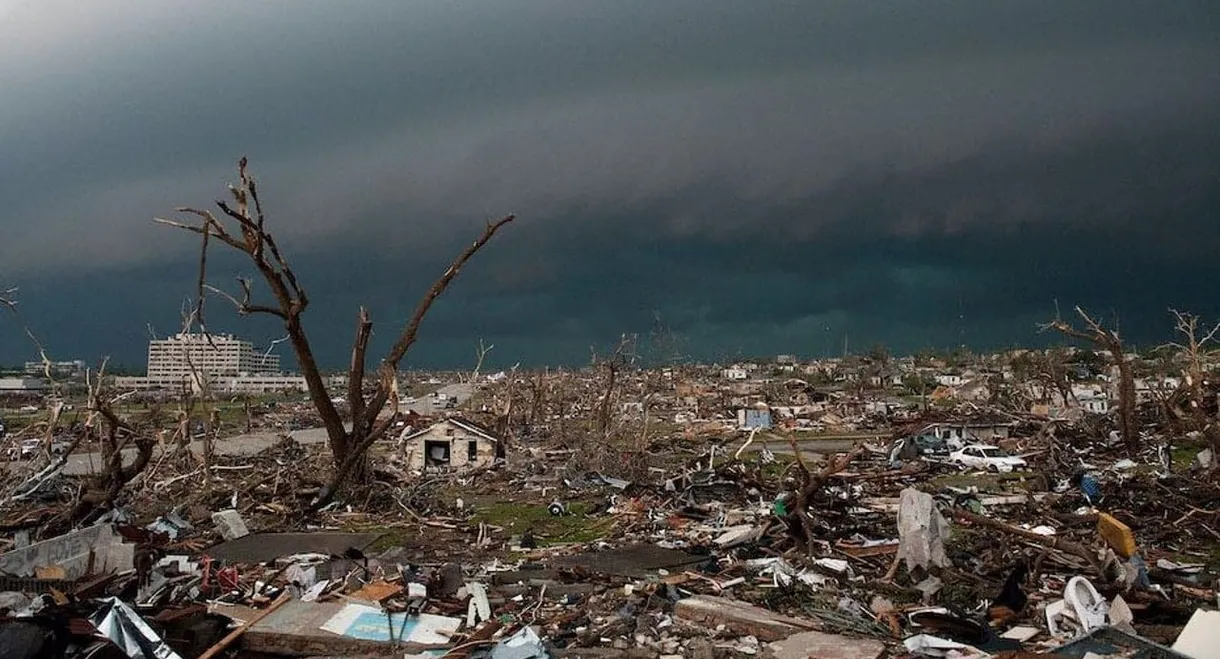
left=399, top=416, right=504, bottom=471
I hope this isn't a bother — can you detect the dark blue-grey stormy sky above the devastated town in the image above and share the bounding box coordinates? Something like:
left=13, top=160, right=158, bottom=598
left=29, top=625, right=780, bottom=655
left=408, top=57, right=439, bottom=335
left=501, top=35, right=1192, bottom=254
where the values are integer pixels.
left=0, top=0, right=1220, bottom=366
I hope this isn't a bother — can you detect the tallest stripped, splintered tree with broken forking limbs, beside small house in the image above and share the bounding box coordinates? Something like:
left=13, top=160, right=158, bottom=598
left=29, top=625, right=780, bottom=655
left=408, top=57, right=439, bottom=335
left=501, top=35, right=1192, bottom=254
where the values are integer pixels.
left=156, top=157, right=514, bottom=509
